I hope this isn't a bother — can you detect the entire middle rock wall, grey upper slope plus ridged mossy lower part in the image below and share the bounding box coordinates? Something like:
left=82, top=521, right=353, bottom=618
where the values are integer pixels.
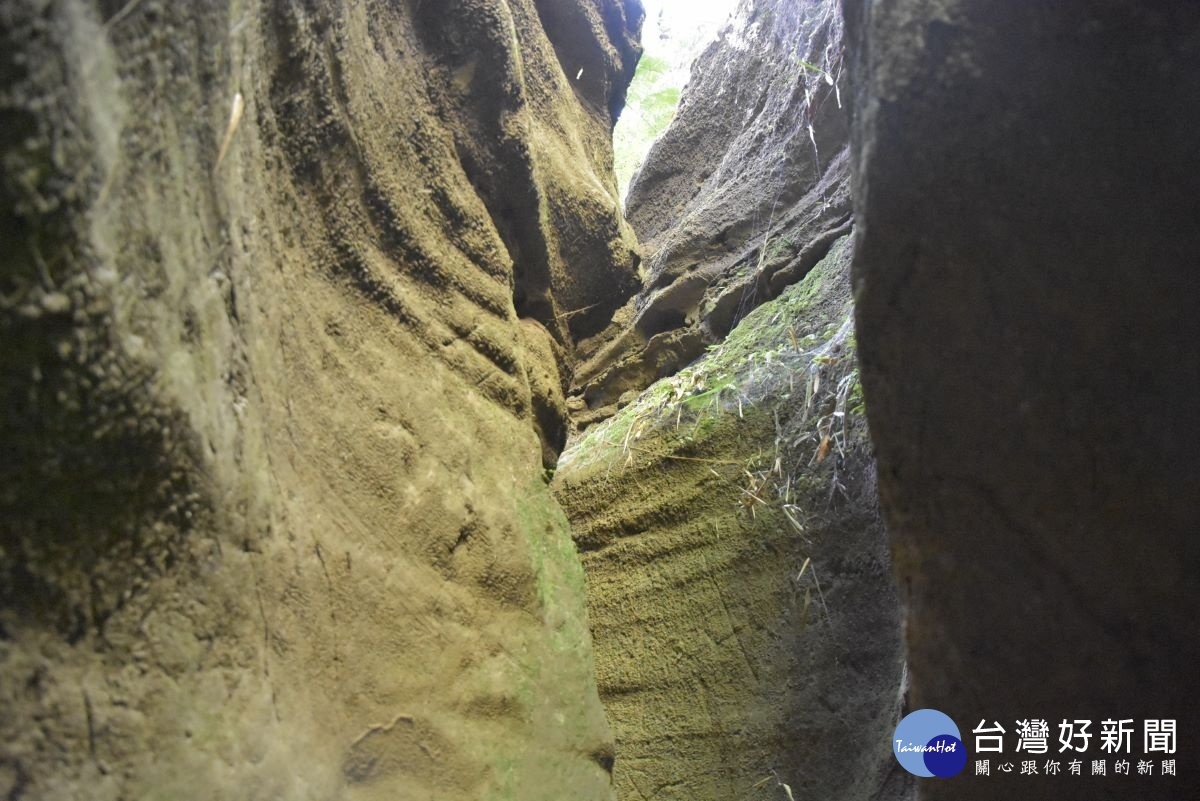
left=556, top=0, right=911, bottom=801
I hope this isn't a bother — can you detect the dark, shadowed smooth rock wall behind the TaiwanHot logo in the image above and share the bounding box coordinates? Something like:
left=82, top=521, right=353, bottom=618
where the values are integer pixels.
left=846, top=0, right=1200, bottom=800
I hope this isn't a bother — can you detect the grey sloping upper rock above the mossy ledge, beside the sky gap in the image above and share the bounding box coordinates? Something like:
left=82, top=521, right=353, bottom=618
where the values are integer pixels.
left=574, top=0, right=851, bottom=427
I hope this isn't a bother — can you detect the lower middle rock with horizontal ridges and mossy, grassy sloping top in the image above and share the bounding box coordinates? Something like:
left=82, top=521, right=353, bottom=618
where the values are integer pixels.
left=554, top=237, right=911, bottom=801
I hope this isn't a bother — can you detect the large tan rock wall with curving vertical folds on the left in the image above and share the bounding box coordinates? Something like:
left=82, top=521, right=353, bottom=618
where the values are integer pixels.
left=0, top=0, right=641, bottom=801
